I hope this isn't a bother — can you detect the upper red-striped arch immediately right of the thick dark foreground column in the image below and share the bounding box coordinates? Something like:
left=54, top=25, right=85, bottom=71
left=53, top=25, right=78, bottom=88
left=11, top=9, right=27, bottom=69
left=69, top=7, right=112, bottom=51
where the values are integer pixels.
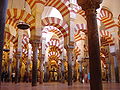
left=99, top=8, right=115, bottom=30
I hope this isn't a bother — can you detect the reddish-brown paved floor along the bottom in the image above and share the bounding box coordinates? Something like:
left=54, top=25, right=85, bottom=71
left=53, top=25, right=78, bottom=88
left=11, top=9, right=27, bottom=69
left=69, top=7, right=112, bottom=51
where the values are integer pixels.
left=0, top=82, right=120, bottom=90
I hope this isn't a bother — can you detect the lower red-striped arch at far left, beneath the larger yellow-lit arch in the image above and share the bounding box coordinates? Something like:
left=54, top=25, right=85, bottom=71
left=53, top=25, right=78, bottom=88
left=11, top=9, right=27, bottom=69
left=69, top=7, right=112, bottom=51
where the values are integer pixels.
left=4, top=32, right=18, bottom=47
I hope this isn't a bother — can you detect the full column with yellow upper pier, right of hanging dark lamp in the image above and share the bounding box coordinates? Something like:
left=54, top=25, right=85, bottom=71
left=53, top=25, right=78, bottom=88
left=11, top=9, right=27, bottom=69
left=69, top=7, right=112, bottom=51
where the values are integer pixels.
left=31, top=3, right=44, bottom=86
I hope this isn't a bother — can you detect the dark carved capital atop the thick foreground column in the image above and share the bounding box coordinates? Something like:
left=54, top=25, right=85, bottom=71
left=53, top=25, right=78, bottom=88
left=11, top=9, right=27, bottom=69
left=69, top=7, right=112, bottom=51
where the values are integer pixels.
left=77, top=0, right=103, bottom=11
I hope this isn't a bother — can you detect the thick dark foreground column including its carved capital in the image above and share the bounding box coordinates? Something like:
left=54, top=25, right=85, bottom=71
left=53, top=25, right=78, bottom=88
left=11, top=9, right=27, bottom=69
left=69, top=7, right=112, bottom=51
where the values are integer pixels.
left=78, top=0, right=102, bottom=90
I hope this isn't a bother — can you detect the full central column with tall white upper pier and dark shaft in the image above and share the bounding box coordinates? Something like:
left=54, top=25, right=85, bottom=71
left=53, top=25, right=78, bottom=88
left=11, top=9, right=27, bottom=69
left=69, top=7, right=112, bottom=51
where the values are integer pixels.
left=66, top=0, right=76, bottom=86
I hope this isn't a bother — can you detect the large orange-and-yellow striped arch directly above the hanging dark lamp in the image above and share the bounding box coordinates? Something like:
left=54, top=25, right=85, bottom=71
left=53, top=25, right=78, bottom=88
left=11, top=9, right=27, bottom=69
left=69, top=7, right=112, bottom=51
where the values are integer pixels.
left=7, top=8, right=35, bottom=30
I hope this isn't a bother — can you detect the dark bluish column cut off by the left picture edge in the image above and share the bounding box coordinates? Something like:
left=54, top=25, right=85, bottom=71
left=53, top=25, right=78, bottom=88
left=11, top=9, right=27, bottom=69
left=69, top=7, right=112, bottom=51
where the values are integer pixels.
left=0, top=0, right=8, bottom=84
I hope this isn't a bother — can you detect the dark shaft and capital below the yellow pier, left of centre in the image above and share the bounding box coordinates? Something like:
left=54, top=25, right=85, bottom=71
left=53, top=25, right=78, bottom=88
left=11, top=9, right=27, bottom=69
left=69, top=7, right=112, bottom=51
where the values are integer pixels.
left=31, top=40, right=40, bottom=86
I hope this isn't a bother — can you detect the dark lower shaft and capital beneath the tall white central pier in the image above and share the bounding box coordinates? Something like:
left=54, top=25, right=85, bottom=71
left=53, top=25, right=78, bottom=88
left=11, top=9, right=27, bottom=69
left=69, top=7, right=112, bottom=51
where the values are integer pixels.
left=67, top=45, right=74, bottom=86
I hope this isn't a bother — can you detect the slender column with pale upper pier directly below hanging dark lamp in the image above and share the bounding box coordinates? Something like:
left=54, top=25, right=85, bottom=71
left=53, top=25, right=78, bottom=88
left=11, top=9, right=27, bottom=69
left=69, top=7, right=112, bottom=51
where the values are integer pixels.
left=15, top=29, right=23, bottom=83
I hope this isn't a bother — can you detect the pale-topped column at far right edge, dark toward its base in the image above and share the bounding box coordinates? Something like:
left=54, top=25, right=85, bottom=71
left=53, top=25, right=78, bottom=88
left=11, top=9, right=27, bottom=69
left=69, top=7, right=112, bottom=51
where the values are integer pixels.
left=109, top=17, right=120, bottom=83
